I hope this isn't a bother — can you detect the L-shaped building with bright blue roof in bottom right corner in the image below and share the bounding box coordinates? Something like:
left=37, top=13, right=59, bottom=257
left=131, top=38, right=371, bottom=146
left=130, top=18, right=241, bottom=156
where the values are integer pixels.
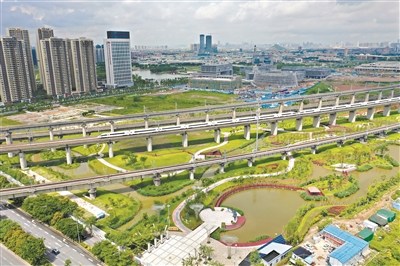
left=321, top=225, right=369, bottom=266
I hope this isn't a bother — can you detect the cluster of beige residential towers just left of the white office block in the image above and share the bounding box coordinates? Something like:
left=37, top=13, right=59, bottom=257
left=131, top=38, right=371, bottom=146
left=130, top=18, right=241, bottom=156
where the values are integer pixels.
left=37, top=28, right=97, bottom=96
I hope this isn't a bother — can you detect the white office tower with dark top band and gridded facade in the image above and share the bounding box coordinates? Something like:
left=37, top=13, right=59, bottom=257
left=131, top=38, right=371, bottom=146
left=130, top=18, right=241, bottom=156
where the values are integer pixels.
left=104, top=31, right=133, bottom=88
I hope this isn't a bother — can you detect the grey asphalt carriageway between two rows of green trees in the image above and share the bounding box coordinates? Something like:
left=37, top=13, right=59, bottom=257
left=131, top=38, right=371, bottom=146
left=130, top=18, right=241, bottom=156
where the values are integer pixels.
left=0, top=203, right=101, bottom=266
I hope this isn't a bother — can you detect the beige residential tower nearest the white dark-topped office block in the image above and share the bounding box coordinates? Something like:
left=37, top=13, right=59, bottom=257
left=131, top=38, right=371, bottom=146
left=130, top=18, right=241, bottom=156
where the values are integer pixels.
left=67, top=38, right=97, bottom=93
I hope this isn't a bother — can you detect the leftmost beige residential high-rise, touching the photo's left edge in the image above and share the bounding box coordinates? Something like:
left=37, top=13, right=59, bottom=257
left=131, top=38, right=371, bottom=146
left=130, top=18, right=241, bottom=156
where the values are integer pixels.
left=0, top=37, right=32, bottom=103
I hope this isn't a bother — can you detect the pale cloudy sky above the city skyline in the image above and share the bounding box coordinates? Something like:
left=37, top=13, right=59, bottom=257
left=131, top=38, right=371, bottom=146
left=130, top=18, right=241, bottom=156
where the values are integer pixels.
left=0, top=0, right=400, bottom=46
